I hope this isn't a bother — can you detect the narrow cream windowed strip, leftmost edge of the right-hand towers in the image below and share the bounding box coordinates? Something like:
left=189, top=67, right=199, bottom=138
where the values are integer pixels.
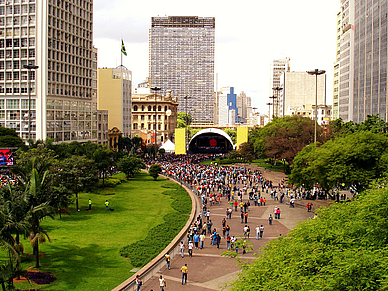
left=332, top=12, right=342, bottom=119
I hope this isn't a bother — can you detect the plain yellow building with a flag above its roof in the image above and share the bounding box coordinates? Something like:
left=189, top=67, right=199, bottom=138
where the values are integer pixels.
left=97, top=66, right=132, bottom=137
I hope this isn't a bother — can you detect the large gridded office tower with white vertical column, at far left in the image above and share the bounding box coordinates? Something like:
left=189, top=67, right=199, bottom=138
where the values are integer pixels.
left=0, top=0, right=101, bottom=142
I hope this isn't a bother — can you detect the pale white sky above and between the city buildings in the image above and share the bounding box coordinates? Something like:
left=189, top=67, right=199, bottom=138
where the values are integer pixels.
left=93, top=0, right=340, bottom=114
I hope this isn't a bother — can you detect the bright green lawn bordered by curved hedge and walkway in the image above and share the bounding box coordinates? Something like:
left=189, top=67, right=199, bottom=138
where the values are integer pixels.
left=4, top=173, right=189, bottom=291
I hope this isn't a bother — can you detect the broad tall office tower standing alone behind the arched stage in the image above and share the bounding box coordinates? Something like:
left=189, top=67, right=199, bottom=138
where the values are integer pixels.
left=149, top=16, right=215, bottom=124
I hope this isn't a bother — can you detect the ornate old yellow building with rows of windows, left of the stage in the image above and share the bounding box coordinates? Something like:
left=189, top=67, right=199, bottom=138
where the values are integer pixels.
left=132, top=88, right=178, bottom=145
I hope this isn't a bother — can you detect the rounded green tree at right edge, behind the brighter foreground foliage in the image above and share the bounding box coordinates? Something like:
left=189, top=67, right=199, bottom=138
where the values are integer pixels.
left=289, top=131, right=388, bottom=191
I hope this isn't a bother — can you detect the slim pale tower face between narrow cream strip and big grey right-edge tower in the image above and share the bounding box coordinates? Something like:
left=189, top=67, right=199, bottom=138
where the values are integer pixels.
left=333, top=0, right=355, bottom=122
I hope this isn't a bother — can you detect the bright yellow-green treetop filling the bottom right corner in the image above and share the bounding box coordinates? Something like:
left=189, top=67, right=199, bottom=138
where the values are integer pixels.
left=229, top=188, right=388, bottom=291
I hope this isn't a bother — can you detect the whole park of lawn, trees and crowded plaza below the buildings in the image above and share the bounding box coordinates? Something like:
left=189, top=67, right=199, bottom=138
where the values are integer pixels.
left=0, top=117, right=388, bottom=290
